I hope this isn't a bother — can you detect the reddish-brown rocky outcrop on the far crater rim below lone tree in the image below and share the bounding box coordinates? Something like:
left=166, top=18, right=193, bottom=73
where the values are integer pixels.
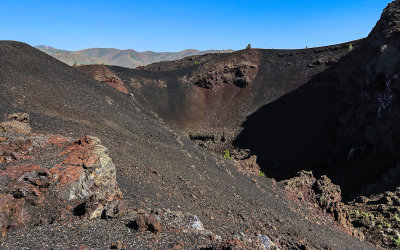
left=181, top=49, right=260, bottom=89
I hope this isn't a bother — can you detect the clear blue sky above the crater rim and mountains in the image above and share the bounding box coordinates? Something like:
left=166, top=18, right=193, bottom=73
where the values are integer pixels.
left=0, top=0, right=391, bottom=51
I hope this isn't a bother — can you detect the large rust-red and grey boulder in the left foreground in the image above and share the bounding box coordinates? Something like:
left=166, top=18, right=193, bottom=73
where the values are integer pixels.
left=0, top=114, right=125, bottom=233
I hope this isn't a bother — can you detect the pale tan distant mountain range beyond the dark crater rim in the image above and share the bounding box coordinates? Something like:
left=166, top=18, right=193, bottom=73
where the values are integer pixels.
left=36, top=45, right=233, bottom=68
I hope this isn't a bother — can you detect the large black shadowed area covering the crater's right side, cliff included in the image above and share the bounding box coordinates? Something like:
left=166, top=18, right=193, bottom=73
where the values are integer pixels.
left=235, top=1, right=400, bottom=199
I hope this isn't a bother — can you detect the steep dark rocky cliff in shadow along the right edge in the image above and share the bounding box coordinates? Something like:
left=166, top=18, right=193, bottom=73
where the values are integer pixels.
left=332, top=1, right=400, bottom=195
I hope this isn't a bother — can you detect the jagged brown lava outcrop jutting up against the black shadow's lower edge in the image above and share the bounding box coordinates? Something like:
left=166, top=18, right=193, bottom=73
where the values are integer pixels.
left=282, top=171, right=360, bottom=236
